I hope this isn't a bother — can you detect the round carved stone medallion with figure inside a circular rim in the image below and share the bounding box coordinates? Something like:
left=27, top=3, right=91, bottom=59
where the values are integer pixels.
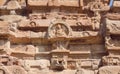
left=48, top=22, right=72, bottom=38
